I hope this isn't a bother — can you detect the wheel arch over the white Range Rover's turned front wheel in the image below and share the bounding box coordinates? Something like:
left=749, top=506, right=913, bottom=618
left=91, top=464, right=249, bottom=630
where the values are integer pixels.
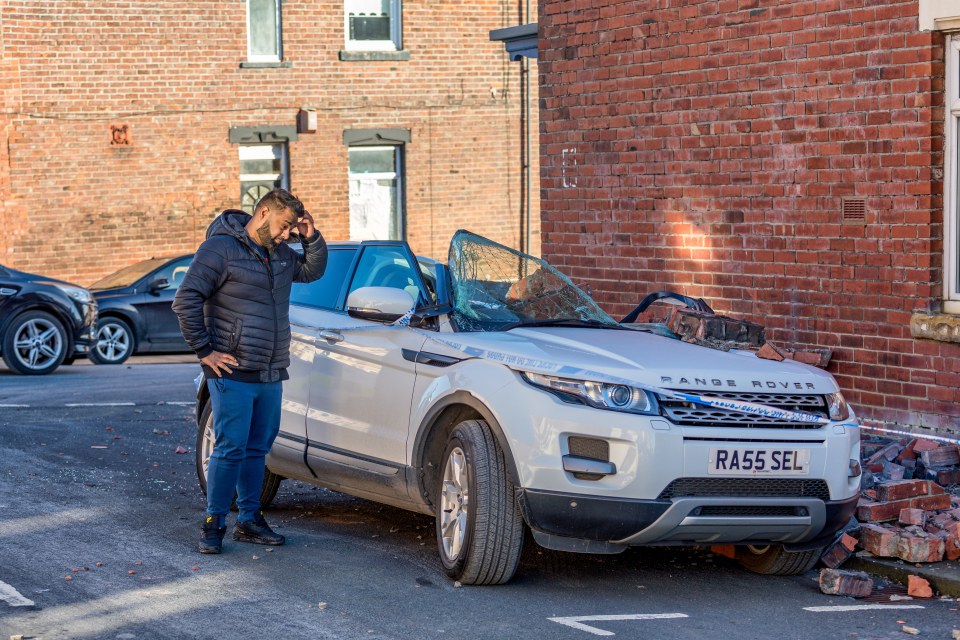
left=412, top=391, right=520, bottom=506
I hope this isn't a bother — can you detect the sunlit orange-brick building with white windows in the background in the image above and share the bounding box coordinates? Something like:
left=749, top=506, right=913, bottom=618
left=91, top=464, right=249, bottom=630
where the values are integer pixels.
left=0, top=0, right=539, bottom=284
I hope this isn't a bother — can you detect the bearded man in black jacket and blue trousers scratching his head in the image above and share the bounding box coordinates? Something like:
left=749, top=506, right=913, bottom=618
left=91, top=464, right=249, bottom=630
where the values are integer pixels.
left=173, top=189, right=327, bottom=553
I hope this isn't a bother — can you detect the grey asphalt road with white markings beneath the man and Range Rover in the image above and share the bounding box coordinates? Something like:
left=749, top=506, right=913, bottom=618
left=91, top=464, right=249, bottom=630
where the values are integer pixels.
left=0, top=358, right=960, bottom=640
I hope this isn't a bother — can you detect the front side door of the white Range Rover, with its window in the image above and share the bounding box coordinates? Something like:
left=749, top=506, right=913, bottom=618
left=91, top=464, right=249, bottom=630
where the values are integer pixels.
left=307, top=242, right=425, bottom=473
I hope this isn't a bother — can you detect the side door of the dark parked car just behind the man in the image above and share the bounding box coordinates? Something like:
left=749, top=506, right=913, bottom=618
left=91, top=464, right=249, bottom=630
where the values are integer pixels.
left=134, top=256, right=193, bottom=351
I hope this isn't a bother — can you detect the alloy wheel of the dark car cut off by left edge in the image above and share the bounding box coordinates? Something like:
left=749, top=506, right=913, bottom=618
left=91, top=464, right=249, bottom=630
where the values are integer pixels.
left=3, top=310, right=70, bottom=376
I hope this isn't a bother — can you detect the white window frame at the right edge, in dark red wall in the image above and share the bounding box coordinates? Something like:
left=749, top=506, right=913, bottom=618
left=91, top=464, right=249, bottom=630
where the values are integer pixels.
left=943, top=33, right=960, bottom=313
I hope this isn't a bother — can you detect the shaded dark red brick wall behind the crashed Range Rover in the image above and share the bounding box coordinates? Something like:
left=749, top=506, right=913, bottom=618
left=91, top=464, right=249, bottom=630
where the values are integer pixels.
left=539, top=0, right=960, bottom=432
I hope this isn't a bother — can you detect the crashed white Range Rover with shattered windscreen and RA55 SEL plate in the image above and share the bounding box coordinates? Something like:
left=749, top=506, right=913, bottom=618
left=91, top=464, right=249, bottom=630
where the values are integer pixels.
left=197, top=231, right=860, bottom=584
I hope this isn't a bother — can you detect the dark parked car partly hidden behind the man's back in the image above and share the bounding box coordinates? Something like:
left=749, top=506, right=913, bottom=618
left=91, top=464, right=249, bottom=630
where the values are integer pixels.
left=89, top=253, right=193, bottom=364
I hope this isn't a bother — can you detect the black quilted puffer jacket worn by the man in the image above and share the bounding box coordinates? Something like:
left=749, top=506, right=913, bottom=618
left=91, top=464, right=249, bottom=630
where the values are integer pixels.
left=173, top=210, right=327, bottom=382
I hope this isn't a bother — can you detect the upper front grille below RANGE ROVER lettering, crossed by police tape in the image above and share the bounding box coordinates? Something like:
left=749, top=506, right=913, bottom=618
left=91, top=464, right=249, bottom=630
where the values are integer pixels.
left=658, top=389, right=829, bottom=429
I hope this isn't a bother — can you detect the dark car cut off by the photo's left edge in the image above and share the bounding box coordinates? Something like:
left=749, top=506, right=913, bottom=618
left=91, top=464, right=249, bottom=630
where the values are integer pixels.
left=0, top=265, right=97, bottom=375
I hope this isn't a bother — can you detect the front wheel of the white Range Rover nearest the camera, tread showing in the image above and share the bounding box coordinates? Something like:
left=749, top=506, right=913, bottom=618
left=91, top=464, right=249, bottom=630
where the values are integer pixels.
left=435, top=420, right=524, bottom=585
